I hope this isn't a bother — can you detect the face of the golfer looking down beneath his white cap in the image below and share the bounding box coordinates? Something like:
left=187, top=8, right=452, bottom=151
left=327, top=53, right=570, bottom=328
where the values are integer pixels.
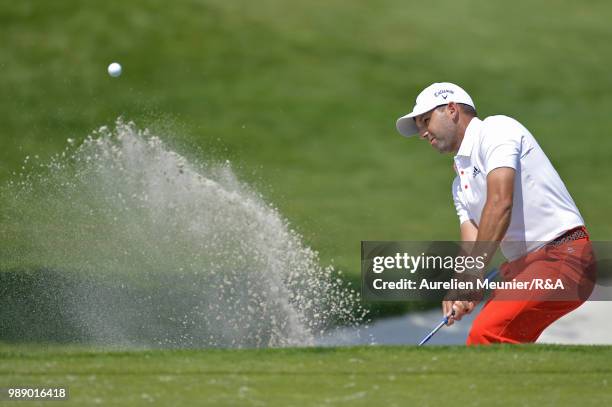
left=415, top=105, right=458, bottom=153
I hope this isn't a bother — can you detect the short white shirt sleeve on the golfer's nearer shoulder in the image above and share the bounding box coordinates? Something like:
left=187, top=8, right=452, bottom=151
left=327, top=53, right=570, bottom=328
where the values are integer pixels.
left=480, top=119, right=523, bottom=174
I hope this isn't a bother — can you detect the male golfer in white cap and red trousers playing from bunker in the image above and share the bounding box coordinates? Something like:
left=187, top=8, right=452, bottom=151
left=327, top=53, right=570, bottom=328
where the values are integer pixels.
left=397, top=83, right=594, bottom=345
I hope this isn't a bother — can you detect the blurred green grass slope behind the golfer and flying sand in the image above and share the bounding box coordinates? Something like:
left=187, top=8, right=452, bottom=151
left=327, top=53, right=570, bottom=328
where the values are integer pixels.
left=0, top=0, right=612, bottom=276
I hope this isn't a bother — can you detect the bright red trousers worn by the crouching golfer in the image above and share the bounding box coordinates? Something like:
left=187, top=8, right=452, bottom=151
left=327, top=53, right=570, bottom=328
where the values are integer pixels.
left=467, top=228, right=595, bottom=345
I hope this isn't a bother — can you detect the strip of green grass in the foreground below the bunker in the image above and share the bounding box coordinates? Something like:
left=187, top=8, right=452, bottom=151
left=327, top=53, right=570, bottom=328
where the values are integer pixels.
left=0, top=345, right=612, bottom=407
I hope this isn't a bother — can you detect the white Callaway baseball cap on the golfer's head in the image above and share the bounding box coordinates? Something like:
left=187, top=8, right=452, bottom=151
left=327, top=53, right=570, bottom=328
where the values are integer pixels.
left=395, top=82, right=476, bottom=137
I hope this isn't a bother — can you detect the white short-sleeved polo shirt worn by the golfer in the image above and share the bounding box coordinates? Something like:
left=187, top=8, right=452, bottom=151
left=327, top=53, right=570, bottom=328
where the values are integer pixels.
left=453, top=116, right=584, bottom=260
